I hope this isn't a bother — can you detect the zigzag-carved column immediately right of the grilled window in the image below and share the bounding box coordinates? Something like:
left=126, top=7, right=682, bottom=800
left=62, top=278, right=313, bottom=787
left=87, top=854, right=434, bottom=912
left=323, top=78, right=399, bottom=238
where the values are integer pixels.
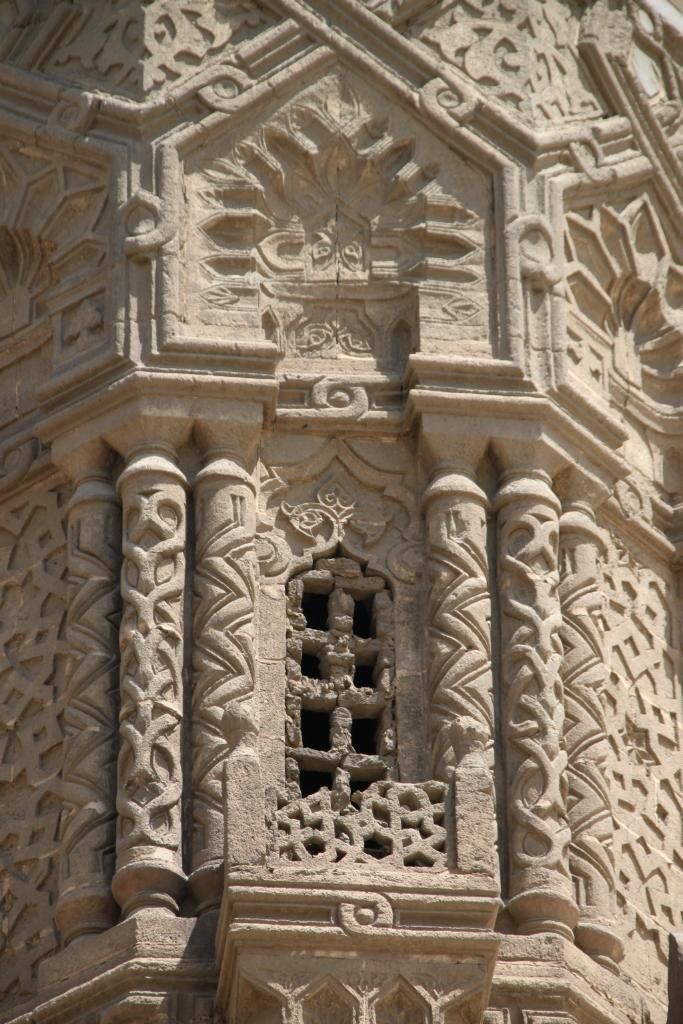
left=425, top=472, right=494, bottom=779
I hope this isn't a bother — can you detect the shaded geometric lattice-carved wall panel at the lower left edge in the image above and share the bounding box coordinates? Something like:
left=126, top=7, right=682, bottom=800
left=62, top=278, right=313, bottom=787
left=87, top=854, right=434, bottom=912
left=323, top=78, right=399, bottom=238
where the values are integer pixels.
left=0, top=489, right=69, bottom=1001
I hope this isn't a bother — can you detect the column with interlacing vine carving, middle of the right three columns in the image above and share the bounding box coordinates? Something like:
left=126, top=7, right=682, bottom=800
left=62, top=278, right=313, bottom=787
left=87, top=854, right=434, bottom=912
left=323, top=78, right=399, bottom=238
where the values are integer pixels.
left=497, top=470, right=577, bottom=939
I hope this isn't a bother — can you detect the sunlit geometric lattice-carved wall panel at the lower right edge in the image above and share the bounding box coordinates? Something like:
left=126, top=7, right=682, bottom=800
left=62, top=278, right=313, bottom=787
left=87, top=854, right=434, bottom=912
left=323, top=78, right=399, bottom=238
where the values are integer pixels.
left=601, top=536, right=683, bottom=1006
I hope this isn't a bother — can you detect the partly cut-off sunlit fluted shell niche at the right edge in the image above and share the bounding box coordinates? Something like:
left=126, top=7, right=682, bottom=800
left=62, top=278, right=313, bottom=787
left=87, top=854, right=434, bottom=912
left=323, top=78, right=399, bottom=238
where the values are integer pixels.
left=566, top=193, right=683, bottom=395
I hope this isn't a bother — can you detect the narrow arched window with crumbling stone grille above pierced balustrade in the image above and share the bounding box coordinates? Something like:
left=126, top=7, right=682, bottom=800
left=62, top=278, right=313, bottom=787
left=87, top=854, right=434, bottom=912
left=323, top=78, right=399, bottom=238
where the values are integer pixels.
left=286, top=558, right=395, bottom=806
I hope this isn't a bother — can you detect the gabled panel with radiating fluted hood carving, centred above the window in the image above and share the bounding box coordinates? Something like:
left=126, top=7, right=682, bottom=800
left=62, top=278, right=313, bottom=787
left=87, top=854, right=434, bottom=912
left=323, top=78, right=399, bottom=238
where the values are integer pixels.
left=185, top=72, right=488, bottom=364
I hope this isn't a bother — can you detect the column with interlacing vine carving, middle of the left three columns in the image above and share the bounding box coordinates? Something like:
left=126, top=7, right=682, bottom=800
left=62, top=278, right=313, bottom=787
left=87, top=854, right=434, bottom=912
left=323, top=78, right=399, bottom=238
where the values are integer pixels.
left=114, top=444, right=185, bottom=914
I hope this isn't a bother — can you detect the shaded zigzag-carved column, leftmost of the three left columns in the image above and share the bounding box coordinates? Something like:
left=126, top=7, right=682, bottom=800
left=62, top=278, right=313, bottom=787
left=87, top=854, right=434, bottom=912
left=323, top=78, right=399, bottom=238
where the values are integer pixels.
left=55, top=471, right=121, bottom=944
